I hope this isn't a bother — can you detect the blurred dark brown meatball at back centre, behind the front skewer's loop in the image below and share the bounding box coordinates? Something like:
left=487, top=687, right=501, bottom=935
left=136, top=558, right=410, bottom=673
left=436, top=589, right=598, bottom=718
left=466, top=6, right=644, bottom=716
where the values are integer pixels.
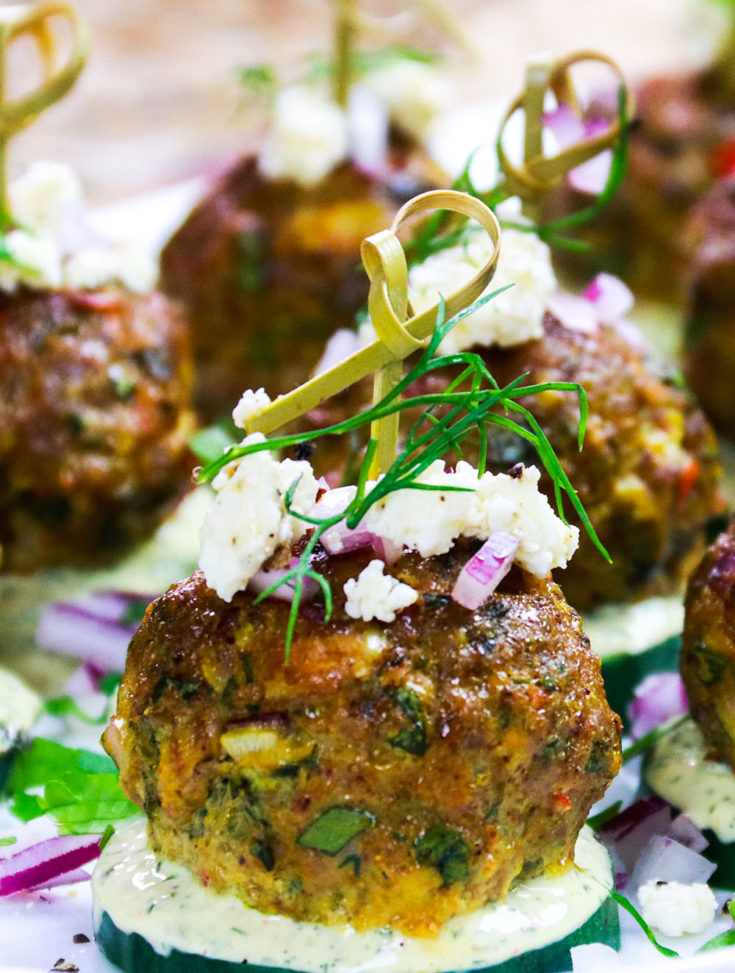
left=161, top=144, right=446, bottom=418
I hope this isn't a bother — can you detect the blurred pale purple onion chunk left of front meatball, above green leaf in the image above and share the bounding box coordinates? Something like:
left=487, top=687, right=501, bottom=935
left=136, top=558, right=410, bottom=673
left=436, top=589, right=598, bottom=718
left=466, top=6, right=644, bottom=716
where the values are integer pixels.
left=36, top=591, right=153, bottom=672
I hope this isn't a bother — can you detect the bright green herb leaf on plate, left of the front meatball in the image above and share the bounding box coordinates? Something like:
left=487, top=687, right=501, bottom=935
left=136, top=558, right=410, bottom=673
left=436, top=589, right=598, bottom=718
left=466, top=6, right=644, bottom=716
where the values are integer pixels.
left=10, top=737, right=140, bottom=834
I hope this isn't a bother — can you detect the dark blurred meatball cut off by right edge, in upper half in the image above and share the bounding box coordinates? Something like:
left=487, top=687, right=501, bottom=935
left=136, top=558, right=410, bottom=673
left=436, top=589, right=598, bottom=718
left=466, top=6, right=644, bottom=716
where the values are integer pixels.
left=684, top=178, right=735, bottom=438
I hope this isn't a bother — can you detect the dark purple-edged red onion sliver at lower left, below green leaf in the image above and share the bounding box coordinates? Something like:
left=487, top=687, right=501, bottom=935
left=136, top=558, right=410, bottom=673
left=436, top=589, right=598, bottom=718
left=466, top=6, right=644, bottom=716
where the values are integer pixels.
left=0, top=835, right=100, bottom=896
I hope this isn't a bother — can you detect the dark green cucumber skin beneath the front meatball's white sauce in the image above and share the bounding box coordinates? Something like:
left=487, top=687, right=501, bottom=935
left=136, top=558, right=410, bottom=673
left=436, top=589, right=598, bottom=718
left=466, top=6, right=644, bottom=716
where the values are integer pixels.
left=95, top=898, right=620, bottom=973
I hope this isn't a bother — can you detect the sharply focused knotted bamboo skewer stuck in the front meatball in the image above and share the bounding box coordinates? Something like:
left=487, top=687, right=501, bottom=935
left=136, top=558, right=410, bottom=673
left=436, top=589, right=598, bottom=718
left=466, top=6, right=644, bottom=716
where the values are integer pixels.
left=247, top=189, right=500, bottom=472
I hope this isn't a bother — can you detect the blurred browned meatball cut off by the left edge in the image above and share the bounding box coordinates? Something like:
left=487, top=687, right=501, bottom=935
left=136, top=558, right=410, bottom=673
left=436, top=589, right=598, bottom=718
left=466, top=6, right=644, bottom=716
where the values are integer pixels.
left=0, top=289, right=193, bottom=572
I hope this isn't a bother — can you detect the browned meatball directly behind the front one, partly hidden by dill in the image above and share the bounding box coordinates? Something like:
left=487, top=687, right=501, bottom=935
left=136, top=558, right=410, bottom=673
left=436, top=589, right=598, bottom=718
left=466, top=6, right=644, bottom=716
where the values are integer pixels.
left=310, top=312, right=723, bottom=610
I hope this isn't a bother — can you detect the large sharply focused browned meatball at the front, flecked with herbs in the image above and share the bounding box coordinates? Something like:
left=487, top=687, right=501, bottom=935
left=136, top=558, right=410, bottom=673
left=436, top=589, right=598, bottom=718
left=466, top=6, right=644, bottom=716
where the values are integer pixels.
left=105, top=542, right=620, bottom=935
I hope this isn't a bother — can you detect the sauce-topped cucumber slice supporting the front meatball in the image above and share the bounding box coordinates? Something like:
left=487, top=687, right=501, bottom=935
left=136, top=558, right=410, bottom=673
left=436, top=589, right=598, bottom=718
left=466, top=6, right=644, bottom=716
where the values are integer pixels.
left=93, top=823, right=620, bottom=973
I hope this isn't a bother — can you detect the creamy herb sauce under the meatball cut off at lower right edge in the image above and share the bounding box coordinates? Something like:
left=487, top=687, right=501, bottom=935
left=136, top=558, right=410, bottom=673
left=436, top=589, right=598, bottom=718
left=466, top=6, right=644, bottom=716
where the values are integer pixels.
left=644, top=719, right=735, bottom=842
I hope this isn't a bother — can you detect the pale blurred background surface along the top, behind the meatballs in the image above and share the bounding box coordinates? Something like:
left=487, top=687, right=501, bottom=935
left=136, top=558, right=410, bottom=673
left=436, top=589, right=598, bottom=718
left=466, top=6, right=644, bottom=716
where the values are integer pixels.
left=2, top=0, right=725, bottom=204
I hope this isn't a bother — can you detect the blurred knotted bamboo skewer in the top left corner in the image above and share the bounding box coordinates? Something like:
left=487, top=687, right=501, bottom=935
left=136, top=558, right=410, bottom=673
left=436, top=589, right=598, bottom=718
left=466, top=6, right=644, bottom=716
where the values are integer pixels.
left=0, top=0, right=89, bottom=229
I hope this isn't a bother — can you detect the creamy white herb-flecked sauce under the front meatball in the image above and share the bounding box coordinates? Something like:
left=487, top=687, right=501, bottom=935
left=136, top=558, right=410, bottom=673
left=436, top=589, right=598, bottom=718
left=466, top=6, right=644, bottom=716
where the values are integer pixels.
left=92, top=821, right=612, bottom=973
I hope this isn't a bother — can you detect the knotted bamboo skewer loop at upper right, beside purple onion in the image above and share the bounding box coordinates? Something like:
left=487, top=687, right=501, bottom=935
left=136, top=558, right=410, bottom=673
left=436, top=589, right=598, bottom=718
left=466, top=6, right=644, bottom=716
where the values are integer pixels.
left=497, top=51, right=634, bottom=215
